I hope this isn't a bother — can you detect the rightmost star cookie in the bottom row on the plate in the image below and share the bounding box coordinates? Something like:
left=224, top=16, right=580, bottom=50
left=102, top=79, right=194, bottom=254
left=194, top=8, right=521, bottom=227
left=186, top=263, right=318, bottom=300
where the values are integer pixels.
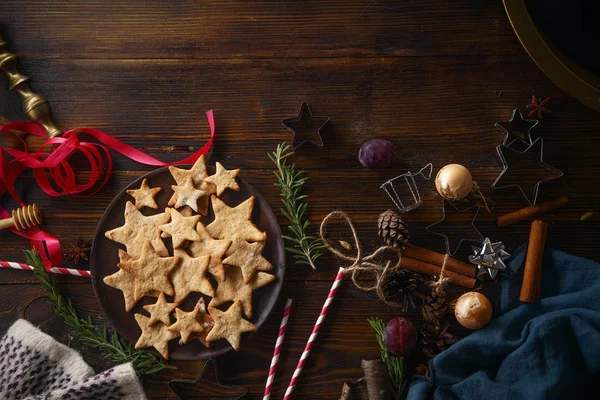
left=206, top=301, right=258, bottom=351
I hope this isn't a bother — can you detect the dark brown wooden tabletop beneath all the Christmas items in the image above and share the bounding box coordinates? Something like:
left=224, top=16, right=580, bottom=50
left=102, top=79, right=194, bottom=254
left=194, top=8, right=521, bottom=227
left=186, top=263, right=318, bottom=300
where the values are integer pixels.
left=0, top=0, right=600, bottom=399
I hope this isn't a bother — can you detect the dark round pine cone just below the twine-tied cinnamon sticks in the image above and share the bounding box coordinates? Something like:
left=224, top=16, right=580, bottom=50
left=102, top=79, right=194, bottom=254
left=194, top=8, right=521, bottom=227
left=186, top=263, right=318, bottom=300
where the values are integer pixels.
left=382, top=269, right=427, bottom=312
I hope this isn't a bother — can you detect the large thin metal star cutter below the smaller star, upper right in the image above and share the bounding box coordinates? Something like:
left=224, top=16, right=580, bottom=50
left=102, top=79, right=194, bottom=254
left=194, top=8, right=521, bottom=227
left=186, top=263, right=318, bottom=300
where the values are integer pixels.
left=492, top=138, right=563, bottom=205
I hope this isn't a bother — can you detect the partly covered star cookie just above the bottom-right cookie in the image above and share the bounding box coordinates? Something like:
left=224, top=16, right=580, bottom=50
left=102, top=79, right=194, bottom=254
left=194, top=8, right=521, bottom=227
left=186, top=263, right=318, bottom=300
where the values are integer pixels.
left=208, top=265, right=275, bottom=318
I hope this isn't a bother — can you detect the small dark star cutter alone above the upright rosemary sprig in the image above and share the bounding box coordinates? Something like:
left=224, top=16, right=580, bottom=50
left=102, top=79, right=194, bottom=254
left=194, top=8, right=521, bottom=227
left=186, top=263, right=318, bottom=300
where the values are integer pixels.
left=281, top=102, right=330, bottom=150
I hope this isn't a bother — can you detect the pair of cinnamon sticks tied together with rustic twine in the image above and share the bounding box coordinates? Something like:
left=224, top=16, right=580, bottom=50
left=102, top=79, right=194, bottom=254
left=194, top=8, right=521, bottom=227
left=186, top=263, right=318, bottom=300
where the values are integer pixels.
left=400, top=243, right=477, bottom=289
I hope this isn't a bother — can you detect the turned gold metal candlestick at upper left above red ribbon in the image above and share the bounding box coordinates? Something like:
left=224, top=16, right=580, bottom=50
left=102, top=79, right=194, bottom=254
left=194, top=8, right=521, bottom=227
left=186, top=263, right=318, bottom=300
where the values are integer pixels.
left=0, top=34, right=62, bottom=138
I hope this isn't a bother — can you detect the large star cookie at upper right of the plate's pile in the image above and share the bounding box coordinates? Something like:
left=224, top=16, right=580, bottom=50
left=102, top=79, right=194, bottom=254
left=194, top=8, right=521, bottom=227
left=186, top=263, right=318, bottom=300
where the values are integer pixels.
left=206, top=195, right=267, bottom=242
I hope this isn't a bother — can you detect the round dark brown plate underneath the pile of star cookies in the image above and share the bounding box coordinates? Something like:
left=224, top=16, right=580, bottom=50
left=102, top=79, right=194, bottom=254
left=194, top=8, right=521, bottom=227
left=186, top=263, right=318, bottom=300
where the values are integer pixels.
left=90, top=168, right=285, bottom=360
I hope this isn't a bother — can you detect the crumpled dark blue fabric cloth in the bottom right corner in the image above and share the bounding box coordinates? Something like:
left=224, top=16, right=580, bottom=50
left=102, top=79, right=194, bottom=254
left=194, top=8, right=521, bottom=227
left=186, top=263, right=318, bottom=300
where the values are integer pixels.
left=407, top=248, right=600, bottom=400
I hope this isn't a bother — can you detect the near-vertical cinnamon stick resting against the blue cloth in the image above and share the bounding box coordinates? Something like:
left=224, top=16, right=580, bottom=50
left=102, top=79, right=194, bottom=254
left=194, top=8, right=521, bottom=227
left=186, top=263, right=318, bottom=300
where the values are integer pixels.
left=519, top=220, right=548, bottom=303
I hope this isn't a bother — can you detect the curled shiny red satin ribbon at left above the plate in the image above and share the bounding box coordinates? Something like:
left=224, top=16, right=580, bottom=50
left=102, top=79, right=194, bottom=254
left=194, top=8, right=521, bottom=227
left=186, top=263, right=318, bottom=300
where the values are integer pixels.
left=0, top=110, right=215, bottom=269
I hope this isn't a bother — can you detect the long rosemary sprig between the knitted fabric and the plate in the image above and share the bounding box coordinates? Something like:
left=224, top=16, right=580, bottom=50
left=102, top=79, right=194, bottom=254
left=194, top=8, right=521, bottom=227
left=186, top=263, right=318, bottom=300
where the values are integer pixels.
left=25, top=249, right=167, bottom=375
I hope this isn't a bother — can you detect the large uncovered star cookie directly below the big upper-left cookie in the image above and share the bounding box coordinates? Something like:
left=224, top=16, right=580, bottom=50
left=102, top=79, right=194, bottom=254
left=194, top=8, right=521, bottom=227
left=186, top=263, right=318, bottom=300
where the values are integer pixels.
left=118, top=240, right=179, bottom=302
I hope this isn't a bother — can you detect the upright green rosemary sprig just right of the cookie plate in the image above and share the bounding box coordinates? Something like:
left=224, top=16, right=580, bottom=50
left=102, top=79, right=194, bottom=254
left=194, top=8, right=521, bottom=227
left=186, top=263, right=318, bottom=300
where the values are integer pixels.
left=268, top=142, right=326, bottom=269
